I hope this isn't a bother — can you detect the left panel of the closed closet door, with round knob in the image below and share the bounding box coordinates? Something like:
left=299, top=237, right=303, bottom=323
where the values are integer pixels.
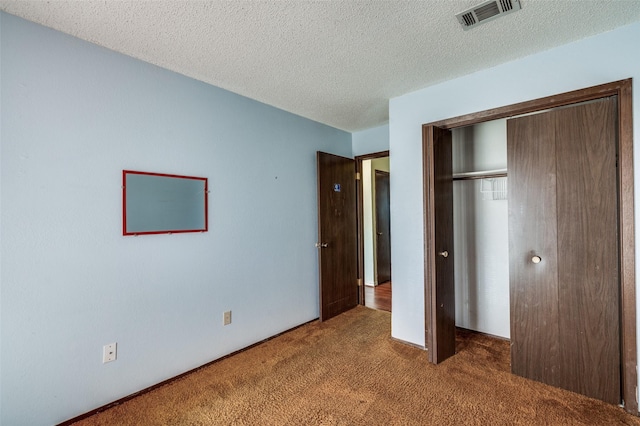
left=507, top=114, right=560, bottom=385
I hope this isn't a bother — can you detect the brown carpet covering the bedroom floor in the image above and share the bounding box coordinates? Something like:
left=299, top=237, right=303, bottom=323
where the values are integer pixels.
left=76, top=307, right=640, bottom=426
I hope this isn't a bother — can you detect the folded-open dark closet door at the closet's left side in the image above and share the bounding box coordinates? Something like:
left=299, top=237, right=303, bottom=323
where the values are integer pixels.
left=423, top=126, right=456, bottom=364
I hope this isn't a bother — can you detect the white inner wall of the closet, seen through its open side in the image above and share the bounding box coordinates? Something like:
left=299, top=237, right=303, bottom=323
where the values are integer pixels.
left=453, top=120, right=510, bottom=338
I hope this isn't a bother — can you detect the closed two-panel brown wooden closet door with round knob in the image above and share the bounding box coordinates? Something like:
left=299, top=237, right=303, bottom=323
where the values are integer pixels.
left=507, top=98, right=621, bottom=404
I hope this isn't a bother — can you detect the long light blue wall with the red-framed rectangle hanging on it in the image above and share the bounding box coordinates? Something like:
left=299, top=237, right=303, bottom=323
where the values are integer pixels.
left=0, top=13, right=352, bottom=426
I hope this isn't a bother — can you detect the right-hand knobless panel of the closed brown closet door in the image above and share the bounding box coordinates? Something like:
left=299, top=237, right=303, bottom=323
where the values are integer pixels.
left=552, top=98, right=620, bottom=404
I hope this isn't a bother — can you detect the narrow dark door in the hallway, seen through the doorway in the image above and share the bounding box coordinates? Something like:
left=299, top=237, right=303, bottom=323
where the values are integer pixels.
left=375, top=170, right=391, bottom=284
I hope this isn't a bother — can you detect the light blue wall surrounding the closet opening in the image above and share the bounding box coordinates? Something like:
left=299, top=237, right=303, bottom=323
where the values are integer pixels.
left=389, top=23, right=640, bottom=345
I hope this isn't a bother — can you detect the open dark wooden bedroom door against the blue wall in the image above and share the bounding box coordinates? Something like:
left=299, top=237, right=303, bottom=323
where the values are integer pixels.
left=317, top=152, right=358, bottom=321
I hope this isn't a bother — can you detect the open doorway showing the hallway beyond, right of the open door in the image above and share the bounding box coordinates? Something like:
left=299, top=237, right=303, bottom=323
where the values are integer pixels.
left=356, top=151, right=392, bottom=312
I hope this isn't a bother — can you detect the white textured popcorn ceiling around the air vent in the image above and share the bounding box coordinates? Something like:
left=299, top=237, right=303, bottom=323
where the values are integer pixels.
left=0, top=0, right=640, bottom=131
